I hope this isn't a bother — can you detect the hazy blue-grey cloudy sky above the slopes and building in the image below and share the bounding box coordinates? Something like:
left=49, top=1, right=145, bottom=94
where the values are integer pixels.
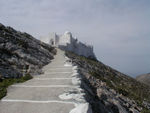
left=0, top=0, right=150, bottom=77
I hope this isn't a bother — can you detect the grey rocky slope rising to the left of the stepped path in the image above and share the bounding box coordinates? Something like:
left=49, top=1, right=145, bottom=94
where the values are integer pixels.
left=0, top=24, right=56, bottom=78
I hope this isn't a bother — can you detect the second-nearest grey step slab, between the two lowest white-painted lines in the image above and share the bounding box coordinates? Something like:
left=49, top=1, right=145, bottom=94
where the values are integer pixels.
left=3, top=85, right=78, bottom=101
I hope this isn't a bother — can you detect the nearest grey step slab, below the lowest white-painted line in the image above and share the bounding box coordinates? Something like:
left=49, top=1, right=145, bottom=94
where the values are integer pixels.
left=0, top=102, right=74, bottom=113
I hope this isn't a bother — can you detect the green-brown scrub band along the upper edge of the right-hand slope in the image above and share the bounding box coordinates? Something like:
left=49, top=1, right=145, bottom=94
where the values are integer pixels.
left=66, top=52, right=150, bottom=113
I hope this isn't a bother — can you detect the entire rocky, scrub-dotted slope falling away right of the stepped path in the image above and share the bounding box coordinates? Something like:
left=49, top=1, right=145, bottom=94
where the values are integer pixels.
left=66, top=52, right=150, bottom=113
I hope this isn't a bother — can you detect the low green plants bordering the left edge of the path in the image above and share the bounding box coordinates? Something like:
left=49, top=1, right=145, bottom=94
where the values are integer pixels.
left=0, top=74, right=32, bottom=99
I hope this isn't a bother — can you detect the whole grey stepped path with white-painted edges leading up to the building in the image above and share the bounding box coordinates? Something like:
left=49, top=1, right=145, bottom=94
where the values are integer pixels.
left=0, top=50, right=89, bottom=113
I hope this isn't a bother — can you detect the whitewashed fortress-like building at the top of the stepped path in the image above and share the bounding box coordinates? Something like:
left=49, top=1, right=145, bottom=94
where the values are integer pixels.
left=49, top=31, right=96, bottom=58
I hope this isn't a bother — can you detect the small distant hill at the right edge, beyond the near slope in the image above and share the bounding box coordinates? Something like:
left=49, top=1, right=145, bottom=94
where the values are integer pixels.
left=136, top=73, right=150, bottom=86
